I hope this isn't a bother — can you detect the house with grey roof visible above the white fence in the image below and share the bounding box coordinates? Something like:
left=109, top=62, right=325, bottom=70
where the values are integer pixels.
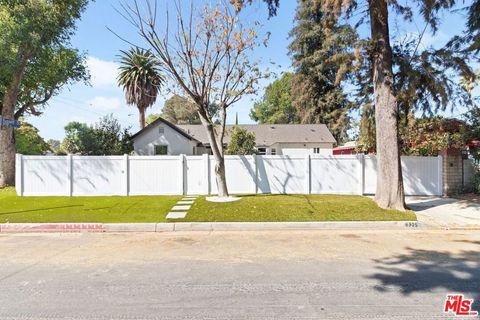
left=132, top=118, right=336, bottom=155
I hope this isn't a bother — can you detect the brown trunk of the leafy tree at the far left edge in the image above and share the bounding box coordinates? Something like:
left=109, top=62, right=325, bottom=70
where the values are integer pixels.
left=0, top=55, right=28, bottom=187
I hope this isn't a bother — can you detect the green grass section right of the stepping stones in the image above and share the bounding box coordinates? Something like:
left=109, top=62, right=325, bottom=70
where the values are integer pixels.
left=181, top=195, right=417, bottom=222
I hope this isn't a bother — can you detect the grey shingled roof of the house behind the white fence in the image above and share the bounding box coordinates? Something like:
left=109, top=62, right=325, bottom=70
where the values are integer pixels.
left=132, top=118, right=336, bottom=146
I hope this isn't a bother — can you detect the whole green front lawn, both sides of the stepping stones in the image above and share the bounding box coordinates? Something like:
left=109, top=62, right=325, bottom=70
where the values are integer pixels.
left=0, top=188, right=416, bottom=223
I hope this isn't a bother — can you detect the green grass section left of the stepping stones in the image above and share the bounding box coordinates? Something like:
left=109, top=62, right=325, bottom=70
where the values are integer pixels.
left=0, top=188, right=181, bottom=223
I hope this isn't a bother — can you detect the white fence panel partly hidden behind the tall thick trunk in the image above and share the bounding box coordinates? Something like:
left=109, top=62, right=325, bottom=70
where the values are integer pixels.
left=364, top=156, right=443, bottom=196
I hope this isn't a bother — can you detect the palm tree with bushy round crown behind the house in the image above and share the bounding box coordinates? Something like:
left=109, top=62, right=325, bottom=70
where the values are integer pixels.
left=118, top=48, right=165, bottom=129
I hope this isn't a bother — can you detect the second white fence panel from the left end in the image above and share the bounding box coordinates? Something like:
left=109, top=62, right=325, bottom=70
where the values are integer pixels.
left=72, top=156, right=125, bottom=196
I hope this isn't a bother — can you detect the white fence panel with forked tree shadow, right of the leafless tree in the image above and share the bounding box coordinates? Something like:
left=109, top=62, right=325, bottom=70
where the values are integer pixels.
left=257, top=156, right=307, bottom=194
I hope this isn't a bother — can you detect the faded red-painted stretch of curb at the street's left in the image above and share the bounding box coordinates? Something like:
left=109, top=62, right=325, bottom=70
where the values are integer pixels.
left=0, top=223, right=105, bottom=233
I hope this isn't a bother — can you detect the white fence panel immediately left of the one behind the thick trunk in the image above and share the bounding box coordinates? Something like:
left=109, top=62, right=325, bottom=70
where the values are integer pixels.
left=311, top=155, right=362, bottom=194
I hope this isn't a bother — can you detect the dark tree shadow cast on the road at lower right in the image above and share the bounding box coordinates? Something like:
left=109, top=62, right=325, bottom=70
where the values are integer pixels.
left=368, top=240, right=480, bottom=311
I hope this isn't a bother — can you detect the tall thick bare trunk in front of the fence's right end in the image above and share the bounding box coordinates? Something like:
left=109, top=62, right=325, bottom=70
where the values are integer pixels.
left=369, top=0, right=405, bottom=210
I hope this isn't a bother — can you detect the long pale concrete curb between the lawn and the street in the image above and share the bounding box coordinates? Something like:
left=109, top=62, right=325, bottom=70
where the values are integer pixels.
left=0, top=221, right=431, bottom=233
